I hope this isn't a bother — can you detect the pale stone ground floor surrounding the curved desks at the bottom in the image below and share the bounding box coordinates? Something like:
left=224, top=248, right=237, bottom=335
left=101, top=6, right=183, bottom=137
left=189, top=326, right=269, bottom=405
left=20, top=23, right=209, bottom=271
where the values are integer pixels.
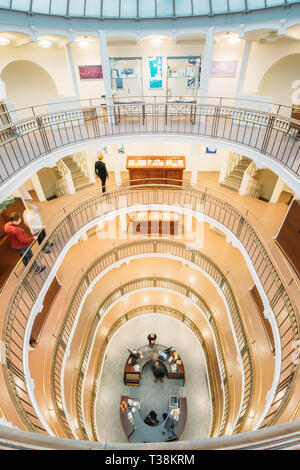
left=96, top=314, right=211, bottom=442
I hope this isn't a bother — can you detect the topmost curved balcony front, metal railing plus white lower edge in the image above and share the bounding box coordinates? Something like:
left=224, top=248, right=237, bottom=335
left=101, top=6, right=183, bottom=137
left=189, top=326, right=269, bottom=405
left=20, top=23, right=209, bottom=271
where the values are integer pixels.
left=0, top=98, right=300, bottom=199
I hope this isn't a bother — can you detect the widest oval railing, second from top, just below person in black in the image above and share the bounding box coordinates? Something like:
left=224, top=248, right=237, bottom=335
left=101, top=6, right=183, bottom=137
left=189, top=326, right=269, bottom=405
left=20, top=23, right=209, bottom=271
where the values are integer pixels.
left=0, top=184, right=299, bottom=440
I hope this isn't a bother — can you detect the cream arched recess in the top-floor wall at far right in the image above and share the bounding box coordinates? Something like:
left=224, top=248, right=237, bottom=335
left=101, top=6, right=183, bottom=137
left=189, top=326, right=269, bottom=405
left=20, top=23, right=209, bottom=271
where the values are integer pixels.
left=258, top=53, right=300, bottom=105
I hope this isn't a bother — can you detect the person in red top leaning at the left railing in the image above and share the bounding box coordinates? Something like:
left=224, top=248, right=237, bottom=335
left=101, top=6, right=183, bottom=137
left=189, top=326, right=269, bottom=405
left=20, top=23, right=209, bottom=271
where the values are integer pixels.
left=4, top=212, right=46, bottom=273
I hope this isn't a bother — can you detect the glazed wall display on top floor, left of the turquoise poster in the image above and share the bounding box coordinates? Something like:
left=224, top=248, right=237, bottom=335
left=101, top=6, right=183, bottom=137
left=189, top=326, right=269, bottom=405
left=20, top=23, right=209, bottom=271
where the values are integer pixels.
left=109, top=57, right=143, bottom=97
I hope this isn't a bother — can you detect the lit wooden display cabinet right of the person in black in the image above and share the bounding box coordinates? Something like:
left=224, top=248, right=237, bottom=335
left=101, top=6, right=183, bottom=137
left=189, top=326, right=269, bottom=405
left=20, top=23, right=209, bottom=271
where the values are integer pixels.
left=126, top=156, right=185, bottom=186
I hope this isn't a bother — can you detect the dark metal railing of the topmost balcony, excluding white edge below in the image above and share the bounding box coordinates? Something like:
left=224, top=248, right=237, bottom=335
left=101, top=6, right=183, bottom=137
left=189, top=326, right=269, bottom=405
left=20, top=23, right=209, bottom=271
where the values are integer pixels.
left=0, top=98, right=300, bottom=196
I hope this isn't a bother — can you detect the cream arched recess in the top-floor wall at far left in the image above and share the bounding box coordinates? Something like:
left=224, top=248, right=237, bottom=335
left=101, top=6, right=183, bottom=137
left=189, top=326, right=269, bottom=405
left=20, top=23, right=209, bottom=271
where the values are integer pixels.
left=1, top=60, right=59, bottom=108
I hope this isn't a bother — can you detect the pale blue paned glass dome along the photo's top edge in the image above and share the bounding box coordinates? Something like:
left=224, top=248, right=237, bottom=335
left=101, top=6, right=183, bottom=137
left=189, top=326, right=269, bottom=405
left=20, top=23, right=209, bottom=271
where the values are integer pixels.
left=0, top=0, right=300, bottom=19
